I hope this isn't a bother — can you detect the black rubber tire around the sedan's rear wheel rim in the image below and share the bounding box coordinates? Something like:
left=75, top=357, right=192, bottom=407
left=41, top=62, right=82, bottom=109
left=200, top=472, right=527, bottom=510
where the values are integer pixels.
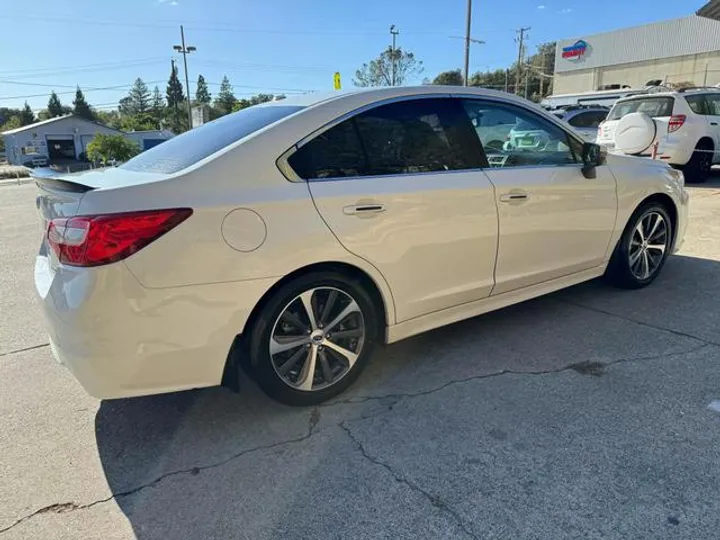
left=248, top=272, right=380, bottom=406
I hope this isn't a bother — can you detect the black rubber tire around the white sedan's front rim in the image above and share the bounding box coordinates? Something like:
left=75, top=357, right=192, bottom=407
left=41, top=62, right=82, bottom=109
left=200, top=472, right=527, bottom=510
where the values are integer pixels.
left=605, top=202, right=675, bottom=289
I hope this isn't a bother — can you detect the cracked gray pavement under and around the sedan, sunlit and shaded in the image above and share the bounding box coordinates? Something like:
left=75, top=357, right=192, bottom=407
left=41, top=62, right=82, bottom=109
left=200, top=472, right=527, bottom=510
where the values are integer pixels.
left=0, top=179, right=720, bottom=540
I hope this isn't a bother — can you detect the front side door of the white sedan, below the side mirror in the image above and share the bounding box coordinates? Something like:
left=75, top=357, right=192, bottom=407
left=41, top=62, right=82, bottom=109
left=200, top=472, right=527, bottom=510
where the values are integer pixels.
left=463, top=99, right=617, bottom=294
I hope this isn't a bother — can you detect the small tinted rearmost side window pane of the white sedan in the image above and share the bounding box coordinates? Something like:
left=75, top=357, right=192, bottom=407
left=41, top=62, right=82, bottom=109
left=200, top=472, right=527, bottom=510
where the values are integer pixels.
left=288, top=120, right=367, bottom=179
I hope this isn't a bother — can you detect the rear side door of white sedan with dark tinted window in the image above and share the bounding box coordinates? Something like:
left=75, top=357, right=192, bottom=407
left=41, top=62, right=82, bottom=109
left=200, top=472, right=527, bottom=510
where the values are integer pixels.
left=288, top=98, right=498, bottom=322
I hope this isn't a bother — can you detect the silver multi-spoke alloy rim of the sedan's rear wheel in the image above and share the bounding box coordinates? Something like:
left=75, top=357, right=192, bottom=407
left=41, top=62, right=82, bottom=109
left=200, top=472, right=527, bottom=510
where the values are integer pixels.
left=269, top=287, right=365, bottom=392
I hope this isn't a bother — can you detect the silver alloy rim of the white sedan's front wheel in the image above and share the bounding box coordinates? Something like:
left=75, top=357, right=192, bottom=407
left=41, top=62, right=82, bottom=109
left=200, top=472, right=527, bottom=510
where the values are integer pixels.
left=628, top=212, right=669, bottom=281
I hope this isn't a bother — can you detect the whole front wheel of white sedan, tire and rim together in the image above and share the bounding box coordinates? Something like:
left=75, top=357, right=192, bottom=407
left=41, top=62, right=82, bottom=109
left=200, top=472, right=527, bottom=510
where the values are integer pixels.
left=605, top=203, right=673, bottom=289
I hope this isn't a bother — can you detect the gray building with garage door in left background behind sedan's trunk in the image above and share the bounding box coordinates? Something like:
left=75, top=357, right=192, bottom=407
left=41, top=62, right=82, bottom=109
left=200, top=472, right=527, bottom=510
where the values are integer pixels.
left=2, top=114, right=173, bottom=165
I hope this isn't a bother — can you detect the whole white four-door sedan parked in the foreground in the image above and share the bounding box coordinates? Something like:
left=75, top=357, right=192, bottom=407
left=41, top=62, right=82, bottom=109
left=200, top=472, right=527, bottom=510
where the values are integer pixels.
left=35, top=86, right=688, bottom=405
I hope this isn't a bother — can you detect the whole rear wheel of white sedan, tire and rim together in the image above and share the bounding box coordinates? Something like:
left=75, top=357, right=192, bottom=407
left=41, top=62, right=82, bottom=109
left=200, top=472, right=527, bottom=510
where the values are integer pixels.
left=250, top=272, right=378, bottom=405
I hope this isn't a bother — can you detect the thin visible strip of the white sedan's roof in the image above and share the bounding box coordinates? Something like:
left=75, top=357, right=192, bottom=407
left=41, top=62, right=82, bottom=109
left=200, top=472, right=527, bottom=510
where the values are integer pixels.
left=262, top=85, right=539, bottom=107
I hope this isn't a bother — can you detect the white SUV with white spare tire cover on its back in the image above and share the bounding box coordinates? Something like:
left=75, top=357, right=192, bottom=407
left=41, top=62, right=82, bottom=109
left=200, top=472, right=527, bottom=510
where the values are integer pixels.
left=597, top=88, right=720, bottom=182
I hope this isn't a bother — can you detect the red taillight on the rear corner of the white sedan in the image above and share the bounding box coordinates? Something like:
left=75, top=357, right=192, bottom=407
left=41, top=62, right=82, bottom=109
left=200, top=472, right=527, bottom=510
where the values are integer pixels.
left=47, top=208, right=192, bottom=266
